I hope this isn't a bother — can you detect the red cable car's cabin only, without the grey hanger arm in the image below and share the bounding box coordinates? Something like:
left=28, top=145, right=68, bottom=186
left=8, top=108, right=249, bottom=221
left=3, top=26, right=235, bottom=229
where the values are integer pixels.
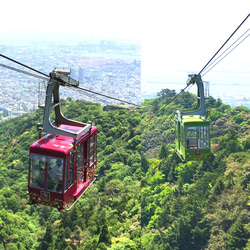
left=28, top=125, right=97, bottom=210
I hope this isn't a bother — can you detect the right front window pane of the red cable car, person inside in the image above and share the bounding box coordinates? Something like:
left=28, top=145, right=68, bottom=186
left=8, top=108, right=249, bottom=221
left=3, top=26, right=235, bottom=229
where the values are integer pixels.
left=47, top=157, right=63, bottom=192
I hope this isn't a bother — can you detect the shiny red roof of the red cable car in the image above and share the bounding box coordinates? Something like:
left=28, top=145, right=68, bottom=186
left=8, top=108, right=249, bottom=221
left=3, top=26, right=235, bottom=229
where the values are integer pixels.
left=30, top=125, right=97, bottom=157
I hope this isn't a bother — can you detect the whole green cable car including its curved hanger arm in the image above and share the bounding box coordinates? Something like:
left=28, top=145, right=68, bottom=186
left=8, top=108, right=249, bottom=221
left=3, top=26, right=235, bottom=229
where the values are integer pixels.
left=175, top=74, right=210, bottom=161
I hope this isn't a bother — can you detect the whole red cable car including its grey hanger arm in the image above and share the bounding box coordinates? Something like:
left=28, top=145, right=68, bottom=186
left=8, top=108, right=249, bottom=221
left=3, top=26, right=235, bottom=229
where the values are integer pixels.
left=28, top=70, right=97, bottom=211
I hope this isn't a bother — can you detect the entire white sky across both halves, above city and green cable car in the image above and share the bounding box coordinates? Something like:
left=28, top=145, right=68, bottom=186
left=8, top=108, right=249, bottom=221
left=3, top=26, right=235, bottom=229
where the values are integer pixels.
left=0, top=0, right=250, bottom=97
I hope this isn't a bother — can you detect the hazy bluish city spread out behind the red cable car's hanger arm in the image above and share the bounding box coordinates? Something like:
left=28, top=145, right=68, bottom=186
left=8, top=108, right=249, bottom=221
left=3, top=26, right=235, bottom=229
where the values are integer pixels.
left=0, top=41, right=141, bottom=120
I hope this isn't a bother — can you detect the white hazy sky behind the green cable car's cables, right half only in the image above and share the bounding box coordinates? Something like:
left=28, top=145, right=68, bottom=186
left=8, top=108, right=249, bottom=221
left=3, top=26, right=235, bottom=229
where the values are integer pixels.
left=142, top=0, right=250, bottom=96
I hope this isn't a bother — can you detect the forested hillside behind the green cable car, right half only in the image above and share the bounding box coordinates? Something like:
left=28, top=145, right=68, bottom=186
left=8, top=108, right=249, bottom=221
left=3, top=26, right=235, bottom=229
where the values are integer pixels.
left=141, top=89, right=250, bottom=250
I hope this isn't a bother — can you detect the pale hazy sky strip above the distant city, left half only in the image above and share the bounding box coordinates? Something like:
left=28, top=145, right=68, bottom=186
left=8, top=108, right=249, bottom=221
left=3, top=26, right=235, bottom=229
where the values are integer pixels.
left=0, top=0, right=141, bottom=39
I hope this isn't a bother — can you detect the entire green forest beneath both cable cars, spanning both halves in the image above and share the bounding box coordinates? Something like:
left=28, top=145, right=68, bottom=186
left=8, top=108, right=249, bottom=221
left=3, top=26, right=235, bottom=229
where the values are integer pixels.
left=0, top=89, right=250, bottom=250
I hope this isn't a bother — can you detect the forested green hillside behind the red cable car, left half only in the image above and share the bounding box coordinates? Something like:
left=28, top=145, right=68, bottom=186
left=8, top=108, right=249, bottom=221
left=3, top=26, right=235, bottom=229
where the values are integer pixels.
left=0, top=99, right=141, bottom=250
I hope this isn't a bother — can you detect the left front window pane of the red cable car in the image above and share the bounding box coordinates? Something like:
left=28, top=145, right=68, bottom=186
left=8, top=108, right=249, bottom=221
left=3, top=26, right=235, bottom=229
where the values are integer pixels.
left=30, top=154, right=46, bottom=189
